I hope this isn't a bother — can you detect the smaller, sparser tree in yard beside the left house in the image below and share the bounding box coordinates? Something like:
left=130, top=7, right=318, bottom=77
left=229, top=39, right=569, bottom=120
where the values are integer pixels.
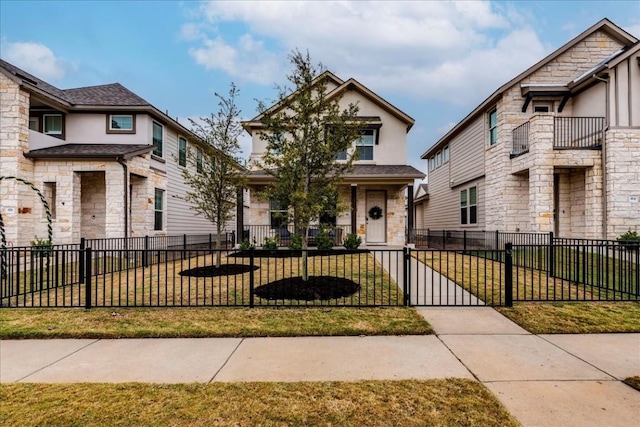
left=181, top=83, right=246, bottom=267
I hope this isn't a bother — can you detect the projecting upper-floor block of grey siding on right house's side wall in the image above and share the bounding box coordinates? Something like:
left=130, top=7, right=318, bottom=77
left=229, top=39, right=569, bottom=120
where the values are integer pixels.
left=450, top=115, right=485, bottom=186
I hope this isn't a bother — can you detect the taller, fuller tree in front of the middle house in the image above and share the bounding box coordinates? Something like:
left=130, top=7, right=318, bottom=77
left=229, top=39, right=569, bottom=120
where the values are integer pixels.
left=258, top=51, right=365, bottom=281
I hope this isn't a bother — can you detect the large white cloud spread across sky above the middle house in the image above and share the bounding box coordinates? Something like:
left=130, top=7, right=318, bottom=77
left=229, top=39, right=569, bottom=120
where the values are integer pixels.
left=183, top=1, right=546, bottom=104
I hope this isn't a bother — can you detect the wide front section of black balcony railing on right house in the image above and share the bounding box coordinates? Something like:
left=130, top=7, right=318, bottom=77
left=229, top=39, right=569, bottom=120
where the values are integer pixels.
left=553, top=117, right=605, bottom=150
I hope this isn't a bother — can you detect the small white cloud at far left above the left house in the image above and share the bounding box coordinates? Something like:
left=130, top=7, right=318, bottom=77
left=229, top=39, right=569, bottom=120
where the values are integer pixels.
left=2, top=40, right=72, bottom=81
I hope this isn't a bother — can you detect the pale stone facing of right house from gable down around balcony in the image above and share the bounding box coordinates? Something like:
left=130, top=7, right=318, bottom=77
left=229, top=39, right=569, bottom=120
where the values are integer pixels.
left=485, top=31, right=622, bottom=236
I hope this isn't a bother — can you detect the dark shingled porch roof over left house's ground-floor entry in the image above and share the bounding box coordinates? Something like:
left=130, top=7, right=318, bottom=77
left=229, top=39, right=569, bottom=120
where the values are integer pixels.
left=25, top=144, right=153, bottom=159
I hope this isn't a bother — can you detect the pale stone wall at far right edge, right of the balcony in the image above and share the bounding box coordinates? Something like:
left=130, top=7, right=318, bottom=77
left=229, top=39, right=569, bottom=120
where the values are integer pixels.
left=606, top=128, right=640, bottom=239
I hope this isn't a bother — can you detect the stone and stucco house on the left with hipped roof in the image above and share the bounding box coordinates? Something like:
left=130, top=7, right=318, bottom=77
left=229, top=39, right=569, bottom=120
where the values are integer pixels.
left=0, top=60, right=240, bottom=246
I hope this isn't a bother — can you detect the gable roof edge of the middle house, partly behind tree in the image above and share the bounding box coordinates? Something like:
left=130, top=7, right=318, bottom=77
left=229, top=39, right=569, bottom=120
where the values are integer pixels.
left=242, top=71, right=415, bottom=134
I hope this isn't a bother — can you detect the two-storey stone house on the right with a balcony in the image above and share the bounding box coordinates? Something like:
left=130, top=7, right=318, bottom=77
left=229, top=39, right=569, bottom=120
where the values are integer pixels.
left=422, top=19, right=640, bottom=239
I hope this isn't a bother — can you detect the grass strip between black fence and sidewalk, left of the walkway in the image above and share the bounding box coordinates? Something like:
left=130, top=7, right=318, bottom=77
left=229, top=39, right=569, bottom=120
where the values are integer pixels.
left=0, top=307, right=433, bottom=339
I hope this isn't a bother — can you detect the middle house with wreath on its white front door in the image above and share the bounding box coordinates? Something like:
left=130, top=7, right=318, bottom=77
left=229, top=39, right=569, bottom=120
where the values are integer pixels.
left=244, top=72, right=424, bottom=245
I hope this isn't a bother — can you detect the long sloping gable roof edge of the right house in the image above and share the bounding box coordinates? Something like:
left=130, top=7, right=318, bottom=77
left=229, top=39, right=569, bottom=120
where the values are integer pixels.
left=420, top=18, right=638, bottom=159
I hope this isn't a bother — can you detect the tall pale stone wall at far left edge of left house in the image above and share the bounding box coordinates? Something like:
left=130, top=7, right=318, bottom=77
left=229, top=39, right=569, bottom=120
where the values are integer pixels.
left=0, top=72, right=35, bottom=246
